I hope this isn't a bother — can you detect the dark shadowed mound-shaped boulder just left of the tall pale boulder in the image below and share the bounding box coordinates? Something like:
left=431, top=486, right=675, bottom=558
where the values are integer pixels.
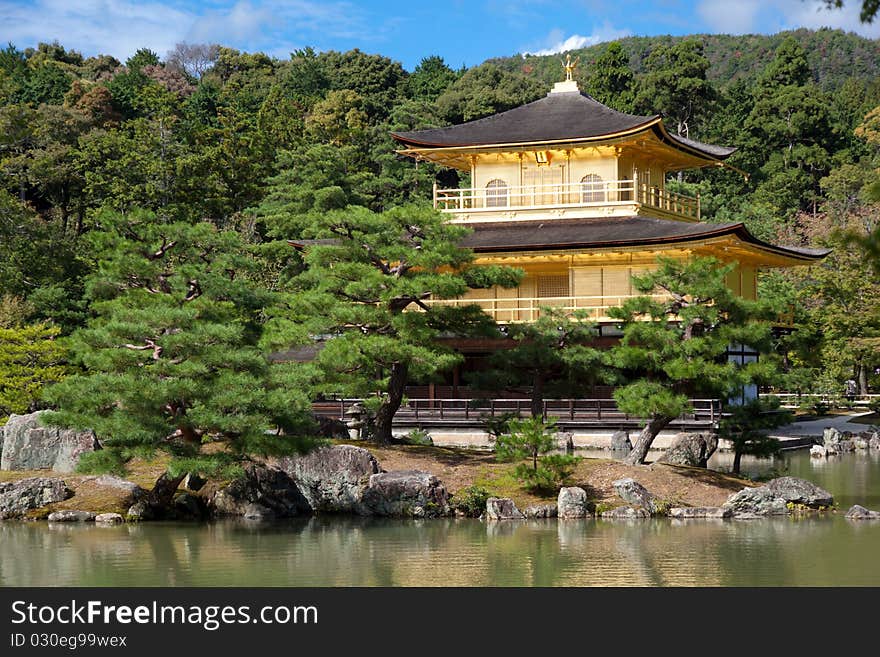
left=208, top=464, right=310, bottom=518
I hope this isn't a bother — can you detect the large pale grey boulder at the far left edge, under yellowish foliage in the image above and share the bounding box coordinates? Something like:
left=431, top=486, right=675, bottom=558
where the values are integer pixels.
left=0, top=411, right=101, bottom=472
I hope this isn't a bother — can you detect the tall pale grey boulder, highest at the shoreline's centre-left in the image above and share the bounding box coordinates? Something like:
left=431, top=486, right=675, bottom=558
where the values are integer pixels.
left=278, top=445, right=380, bottom=515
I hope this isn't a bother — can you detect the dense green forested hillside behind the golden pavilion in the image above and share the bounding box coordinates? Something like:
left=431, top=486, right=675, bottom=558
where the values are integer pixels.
left=0, top=30, right=880, bottom=417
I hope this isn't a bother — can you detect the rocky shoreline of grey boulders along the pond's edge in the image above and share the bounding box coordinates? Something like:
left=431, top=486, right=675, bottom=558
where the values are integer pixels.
left=0, top=414, right=880, bottom=524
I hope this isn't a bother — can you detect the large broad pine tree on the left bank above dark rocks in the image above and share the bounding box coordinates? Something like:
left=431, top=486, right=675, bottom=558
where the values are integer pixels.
left=47, top=214, right=311, bottom=482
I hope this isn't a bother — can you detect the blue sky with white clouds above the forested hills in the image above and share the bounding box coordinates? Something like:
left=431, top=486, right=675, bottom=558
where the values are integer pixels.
left=0, top=0, right=880, bottom=70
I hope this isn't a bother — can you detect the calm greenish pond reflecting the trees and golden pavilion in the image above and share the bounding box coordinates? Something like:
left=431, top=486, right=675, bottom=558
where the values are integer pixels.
left=0, top=450, right=880, bottom=586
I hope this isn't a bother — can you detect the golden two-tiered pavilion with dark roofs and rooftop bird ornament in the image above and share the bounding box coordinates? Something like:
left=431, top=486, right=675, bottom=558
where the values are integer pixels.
left=393, top=73, right=827, bottom=329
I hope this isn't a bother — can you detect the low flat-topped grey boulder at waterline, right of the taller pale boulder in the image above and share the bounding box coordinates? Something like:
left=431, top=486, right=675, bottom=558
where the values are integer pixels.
left=363, top=470, right=450, bottom=518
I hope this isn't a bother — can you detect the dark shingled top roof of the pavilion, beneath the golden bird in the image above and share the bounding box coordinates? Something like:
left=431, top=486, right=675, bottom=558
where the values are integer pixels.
left=392, top=91, right=736, bottom=159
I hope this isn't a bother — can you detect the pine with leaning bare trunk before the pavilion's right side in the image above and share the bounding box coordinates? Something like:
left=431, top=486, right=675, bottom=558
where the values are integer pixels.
left=608, top=258, right=774, bottom=464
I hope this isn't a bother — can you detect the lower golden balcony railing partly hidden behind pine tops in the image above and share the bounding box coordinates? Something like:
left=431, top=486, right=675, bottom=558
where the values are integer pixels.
left=425, top=294, right=668, bottom=324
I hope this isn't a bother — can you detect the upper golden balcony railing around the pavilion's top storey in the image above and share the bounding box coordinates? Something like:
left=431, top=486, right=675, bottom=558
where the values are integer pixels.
left=434, top=180, right=700, bottom=221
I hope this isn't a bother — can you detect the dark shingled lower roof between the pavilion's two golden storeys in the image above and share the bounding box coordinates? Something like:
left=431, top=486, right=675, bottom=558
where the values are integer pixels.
left=461, top=216, right=831, bottom=260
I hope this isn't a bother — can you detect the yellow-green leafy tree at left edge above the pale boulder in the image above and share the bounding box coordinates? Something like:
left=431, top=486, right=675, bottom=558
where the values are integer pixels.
left=0, top=317, right=67, bottom=424
